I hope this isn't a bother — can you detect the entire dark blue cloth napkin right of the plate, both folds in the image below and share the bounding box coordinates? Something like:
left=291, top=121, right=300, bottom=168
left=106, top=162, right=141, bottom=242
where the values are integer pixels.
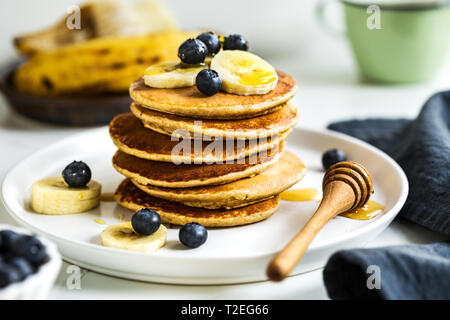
left=323, top=91, right=450, bottom=299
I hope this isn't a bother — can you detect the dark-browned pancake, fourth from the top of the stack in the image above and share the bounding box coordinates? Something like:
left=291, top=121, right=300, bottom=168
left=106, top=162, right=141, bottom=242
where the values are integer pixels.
left=113, top=143, right=284, bottom=188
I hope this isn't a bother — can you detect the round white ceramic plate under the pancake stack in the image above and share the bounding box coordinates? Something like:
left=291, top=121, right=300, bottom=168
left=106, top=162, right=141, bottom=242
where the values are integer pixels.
left=2, top=128, right=408, bottom=284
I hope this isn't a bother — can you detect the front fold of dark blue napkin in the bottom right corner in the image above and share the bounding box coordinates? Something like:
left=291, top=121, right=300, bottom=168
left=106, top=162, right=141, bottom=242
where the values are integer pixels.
left=323, top=242, right=450, bottom=300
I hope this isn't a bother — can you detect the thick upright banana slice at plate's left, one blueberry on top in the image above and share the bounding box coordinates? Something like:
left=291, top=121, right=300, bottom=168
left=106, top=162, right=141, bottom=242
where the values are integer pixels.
left=30, top=177, right=102, bottom=215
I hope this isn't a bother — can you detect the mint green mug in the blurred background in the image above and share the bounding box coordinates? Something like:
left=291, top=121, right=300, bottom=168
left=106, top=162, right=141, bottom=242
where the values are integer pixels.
left=317, top=0, right=450, bottom=83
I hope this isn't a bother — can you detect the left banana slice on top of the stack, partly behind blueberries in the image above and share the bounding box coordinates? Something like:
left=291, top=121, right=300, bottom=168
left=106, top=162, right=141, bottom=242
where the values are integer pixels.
left=143, top=61, right=208, bottom=88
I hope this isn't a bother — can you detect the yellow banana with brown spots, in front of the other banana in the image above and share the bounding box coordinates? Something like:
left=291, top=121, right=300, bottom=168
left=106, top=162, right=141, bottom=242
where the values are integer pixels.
left=14, top=31, right=198, bottom=96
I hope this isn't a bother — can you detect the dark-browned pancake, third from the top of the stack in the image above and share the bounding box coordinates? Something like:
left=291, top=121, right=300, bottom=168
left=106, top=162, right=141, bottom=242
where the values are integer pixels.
left=109, top=113, right=289, bottom=163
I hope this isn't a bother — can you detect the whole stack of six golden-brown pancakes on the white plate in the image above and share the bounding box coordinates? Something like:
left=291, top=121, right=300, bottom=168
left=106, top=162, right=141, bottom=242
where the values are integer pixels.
left=109, top=72, right=305, bottom=227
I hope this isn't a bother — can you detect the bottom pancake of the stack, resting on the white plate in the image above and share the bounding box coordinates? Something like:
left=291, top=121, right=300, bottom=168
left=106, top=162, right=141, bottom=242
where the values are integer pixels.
left=114, top=179, right=280, bottom=227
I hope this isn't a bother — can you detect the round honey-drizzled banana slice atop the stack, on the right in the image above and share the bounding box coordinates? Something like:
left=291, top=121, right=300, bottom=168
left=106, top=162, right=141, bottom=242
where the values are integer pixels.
left=211, top=50, right=278, bottom=96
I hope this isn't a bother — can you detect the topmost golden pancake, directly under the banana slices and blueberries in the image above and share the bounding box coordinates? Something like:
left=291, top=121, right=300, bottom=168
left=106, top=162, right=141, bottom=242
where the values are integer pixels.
left=130, top=71, right=297, bottom=120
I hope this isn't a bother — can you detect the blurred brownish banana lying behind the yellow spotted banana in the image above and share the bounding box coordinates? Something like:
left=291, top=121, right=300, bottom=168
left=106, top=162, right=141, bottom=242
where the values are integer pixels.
left=14, top=0, right=177, bottom=56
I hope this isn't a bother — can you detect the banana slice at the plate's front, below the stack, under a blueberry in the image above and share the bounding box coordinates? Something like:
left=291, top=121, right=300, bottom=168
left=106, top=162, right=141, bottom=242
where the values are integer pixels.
left=101, top=221, right=167, bottom=252
